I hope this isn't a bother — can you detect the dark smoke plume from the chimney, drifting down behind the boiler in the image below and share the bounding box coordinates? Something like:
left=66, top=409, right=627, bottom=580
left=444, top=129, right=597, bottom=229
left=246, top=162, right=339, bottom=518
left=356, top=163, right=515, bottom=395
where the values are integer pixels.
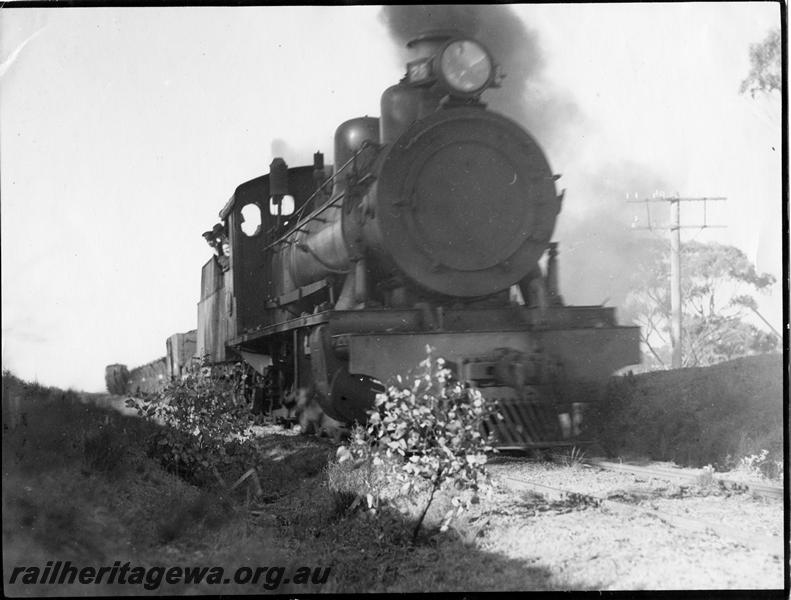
left=381, top=5, right=670, bottom=314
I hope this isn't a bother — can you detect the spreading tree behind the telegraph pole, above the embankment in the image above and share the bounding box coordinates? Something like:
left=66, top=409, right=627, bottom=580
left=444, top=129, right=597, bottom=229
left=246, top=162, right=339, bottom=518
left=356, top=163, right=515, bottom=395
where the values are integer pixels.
left=624, top=240, right=779, bottom=368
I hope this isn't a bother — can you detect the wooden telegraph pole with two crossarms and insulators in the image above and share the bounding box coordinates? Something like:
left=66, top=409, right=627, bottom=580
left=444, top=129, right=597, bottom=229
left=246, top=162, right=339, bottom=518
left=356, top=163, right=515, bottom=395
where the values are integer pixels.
left=627, top=194, right=726, bottom=369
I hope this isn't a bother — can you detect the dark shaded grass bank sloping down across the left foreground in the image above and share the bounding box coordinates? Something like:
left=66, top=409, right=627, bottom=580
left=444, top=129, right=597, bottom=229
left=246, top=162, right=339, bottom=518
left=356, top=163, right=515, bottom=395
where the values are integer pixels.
left=2, top=373, right=579, bottom=595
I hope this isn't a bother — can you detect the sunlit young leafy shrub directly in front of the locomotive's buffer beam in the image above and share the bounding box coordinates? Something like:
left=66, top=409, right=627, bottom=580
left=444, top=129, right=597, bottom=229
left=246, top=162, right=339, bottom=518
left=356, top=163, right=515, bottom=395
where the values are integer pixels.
left=339, top=348, right=502, bottom=539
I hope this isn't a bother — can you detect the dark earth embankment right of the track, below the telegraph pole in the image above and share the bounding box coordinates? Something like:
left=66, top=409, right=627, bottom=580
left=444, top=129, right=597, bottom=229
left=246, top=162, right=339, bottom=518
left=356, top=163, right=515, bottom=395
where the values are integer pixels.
left=590, top=354, right=783, bottom=468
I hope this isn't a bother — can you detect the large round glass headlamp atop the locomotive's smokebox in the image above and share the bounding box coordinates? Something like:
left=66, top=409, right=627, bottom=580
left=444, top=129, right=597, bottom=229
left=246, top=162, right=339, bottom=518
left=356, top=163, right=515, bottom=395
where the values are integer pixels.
left=438, top=39, right=494, bottom=95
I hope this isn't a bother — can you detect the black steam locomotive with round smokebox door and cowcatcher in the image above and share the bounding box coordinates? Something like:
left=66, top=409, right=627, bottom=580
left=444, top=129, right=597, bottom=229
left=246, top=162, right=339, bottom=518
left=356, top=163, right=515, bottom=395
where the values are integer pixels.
left=114, top=31, right=640, bottom=447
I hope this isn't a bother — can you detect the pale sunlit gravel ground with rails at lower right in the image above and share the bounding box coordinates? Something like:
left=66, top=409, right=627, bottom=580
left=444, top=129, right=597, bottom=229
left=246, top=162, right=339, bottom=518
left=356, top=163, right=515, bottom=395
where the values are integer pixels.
left=470, top=463, right=783, bottom=590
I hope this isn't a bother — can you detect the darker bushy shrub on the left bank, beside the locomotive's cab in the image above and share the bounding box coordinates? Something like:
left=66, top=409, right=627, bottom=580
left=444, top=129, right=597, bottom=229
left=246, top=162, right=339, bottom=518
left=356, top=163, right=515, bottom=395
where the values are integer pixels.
left=126, top=373, right=252, bottom=483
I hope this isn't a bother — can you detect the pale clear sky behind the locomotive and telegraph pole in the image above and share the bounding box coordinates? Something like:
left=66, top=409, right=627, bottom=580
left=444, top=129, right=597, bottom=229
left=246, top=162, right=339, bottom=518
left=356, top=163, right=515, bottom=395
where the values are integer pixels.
left=0, top=2, right=782, bottom=391
